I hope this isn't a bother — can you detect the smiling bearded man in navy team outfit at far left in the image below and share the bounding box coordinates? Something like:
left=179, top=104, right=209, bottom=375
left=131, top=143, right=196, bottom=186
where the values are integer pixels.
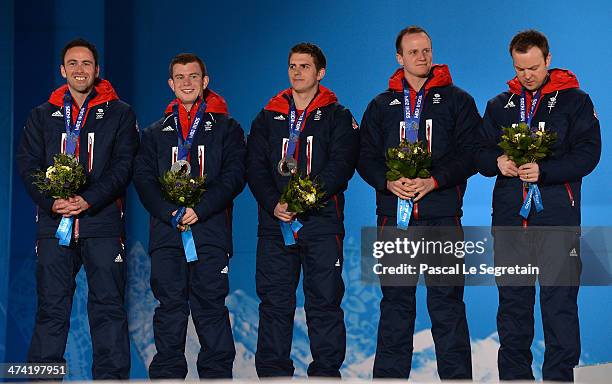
left=17, top=39, right=138, bottom=379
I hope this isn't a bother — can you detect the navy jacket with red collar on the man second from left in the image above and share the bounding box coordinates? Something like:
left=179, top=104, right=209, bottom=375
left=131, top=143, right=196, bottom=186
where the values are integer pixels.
left=134, top=90, right=246, bottom=255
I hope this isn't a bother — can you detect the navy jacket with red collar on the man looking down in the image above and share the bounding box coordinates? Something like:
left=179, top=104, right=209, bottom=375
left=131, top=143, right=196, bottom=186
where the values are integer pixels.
left=477, top=69, right=601, bottom=226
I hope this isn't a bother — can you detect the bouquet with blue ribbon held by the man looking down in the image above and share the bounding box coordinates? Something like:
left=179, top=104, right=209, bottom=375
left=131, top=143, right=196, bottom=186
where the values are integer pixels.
left=498, top=123, right=557, bottom=219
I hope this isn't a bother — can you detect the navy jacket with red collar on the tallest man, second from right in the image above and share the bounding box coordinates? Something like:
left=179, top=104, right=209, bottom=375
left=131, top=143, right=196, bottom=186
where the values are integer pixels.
left=357, top=65, right=481, bottom=220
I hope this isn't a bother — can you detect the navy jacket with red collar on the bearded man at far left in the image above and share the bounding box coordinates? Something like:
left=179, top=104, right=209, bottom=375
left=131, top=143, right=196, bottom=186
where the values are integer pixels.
left=16, top=80, right=138, bottom=238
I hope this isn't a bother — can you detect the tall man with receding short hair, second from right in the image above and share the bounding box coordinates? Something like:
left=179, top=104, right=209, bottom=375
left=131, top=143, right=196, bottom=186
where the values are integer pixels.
left=357, top=26, right=481, bottom=380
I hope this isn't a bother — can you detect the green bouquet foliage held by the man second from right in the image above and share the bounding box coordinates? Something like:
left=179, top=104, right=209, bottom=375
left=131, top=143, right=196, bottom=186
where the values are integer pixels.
left=387, top=139, right=431, bottom=181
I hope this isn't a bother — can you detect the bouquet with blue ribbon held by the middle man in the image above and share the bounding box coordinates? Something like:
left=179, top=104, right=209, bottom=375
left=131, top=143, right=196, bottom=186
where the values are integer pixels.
left=280, top=172, right=325, bottom=245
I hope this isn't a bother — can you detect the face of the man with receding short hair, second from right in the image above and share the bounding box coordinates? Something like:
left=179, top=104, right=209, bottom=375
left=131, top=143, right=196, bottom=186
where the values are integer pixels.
left=396, top=32, right=433, bottom=77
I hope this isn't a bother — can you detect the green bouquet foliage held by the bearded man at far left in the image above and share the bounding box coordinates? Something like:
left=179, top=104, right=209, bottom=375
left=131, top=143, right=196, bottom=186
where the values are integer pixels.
left=32, top=153, right=85, bottom=199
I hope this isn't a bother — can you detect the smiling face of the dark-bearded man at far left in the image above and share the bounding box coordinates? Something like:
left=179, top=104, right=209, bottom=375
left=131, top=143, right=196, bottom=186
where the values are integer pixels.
left=60, top=47, right=100, bottom=93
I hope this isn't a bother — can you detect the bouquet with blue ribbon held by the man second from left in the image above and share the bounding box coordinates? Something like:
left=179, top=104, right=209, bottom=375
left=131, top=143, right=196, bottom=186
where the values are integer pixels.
left=159, top=164, right=206, bottom=262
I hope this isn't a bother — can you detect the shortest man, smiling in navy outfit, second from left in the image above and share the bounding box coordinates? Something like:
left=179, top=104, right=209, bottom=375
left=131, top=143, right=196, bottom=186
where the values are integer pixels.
left=134, top=53, right=246, bottom=379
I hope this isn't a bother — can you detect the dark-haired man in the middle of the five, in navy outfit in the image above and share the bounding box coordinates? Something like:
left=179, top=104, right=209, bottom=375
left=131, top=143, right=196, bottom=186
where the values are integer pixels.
left=247, top=43, right=359, bottom=377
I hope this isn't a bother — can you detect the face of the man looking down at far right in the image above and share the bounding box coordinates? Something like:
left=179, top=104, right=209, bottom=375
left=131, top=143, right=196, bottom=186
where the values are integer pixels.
left=512, top=46, right=550, bottom=91
